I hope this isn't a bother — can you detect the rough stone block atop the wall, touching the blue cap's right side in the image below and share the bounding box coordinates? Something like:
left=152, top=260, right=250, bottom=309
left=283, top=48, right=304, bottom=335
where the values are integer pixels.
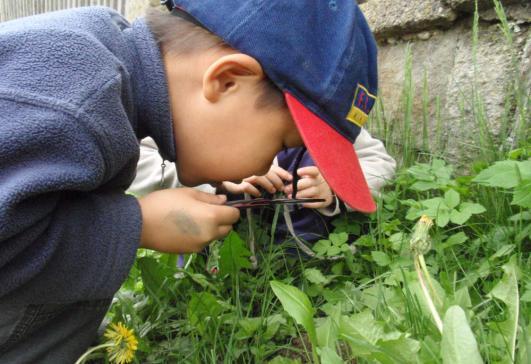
left=360, top=0, right=456, bottom=38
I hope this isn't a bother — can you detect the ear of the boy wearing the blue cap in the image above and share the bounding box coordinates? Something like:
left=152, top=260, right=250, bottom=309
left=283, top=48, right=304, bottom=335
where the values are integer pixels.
left=203, top=53, right=264, bottom=102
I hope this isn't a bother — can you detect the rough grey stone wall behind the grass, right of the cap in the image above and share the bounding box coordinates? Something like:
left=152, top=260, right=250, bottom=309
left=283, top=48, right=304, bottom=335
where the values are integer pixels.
left=360, top=0, right=531, bottom=161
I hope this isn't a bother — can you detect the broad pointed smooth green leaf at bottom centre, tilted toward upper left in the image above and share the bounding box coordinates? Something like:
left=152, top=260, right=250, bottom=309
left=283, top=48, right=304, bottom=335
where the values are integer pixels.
left=270, top=281, right=317, bottom=351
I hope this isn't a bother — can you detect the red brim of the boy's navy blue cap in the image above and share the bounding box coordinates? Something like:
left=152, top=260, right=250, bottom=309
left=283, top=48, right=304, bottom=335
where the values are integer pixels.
left=284, top=92, right=376, bottom=213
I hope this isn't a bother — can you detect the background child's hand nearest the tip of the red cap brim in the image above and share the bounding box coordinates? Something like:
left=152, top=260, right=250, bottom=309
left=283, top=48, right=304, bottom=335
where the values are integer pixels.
left=284, top=166, right=334, bottom=209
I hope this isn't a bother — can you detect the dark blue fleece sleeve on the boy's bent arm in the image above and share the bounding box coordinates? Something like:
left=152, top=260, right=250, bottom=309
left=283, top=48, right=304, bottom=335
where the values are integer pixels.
left=0, top=82, right=142, bottom=304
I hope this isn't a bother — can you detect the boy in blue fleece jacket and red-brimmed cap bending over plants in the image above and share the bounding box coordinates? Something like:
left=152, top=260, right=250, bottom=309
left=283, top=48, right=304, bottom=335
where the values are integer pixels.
left=0, top=0, right=377, bottom=363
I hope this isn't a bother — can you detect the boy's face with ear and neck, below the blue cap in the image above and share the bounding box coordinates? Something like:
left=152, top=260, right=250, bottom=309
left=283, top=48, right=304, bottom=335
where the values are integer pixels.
left=165, top=52, right=302, bottom=186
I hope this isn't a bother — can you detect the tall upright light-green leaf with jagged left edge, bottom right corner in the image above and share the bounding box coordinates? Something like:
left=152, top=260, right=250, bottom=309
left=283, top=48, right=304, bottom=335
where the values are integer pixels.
left=489, top=255, right=520, bottom=362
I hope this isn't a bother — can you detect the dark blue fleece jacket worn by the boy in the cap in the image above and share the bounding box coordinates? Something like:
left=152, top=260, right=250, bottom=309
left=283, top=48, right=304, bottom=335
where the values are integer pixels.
left=0, top=8, right=175, bottom=303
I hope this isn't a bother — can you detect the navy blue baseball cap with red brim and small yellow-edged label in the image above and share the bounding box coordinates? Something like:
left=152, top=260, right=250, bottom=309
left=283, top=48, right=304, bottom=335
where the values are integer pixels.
left=162, top=0, right=378, bottom=212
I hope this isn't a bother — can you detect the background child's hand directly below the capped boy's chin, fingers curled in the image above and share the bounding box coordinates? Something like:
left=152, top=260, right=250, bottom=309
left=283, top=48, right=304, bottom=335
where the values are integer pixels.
left=221, top=166, right=293, bottom=197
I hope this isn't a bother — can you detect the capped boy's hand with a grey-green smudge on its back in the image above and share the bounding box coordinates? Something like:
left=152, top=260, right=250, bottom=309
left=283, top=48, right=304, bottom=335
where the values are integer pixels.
left=138, top=188, right=240, bottom=253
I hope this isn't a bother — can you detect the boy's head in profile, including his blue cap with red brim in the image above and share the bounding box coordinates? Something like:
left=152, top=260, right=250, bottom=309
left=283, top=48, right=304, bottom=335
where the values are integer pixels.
left=151, top=0, right=377, bottom=212
